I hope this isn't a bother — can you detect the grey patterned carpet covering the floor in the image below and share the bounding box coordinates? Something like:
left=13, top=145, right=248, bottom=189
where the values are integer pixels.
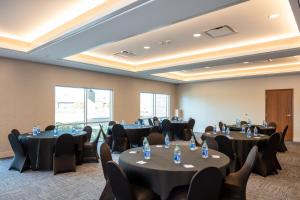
left=0, top=143, right=300, bottom=200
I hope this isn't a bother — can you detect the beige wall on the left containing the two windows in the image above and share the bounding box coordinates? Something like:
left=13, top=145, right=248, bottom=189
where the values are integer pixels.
left=0, top=58, right=177, bottom=157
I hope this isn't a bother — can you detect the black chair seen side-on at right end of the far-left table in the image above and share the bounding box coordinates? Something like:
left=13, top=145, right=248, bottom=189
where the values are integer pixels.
left=83, top=125, right=103, bottom=162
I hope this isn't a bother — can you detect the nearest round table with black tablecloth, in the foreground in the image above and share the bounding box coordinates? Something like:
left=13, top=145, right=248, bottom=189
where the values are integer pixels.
left=119, top=145, right=230, bottom=199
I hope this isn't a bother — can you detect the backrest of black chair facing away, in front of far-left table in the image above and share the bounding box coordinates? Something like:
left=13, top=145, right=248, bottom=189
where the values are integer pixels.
left=54, top=134, right=75, bottom=157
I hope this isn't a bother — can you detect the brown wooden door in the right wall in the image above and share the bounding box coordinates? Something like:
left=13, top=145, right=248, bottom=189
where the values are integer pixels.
left=265, top=89, right=293, bottom=141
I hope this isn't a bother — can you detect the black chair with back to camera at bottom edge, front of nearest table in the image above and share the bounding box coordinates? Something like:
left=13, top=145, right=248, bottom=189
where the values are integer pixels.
left=169, top=167, right=224, bottom=200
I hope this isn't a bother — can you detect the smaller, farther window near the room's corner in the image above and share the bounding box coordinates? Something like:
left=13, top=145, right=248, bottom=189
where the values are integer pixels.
left=140, top=93, right=170, bottom=118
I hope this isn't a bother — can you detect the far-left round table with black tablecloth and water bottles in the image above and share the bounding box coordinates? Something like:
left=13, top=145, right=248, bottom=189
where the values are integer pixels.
left=19, top=131, right=87, bottom=170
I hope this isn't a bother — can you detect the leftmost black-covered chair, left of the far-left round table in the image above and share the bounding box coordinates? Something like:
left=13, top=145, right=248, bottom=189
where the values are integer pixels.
left=8, top=129, right=29, bottom=173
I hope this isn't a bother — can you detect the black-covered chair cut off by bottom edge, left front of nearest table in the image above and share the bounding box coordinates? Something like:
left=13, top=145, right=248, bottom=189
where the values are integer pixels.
left=106, top=161, right=156, bottom=200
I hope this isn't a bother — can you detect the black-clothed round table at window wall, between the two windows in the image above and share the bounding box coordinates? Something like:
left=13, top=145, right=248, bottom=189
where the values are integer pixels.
left=108, top=124, right=152, bottom=146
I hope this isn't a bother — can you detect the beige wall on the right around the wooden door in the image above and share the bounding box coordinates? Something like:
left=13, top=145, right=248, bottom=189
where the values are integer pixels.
left=178, top=75, right=300, bottom=141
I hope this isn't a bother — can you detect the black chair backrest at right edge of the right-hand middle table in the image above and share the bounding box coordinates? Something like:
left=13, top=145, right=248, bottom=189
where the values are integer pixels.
left=263, top=133, right=280, bottom=159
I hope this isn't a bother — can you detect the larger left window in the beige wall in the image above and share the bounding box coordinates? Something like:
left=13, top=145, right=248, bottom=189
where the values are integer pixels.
left=55, top=87, right=112, bottom=124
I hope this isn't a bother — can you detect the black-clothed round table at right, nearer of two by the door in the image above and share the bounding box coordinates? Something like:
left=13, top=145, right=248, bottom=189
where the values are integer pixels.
left=203, top=131, right=269, bottom=166
